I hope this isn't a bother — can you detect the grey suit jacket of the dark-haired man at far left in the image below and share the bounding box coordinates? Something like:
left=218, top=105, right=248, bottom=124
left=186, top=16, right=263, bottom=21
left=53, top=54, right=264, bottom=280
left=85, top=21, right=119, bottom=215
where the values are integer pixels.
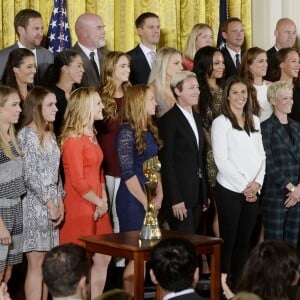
left=0, top=43, right=54, bottom=85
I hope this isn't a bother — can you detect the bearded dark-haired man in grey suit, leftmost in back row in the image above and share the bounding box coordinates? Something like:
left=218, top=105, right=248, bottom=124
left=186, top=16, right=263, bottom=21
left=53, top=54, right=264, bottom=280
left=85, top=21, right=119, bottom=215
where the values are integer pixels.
left=0, top=9, right=53, bottom=85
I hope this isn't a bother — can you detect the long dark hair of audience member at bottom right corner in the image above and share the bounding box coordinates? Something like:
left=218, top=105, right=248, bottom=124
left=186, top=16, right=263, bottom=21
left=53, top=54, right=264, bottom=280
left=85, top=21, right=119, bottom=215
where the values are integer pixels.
left=237, top=241, right=300, bottom=300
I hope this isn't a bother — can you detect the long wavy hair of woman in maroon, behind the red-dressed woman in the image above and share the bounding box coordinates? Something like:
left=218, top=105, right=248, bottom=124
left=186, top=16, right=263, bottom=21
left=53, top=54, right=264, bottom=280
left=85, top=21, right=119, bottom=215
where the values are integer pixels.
left=99, top=51, right=131, bottom=119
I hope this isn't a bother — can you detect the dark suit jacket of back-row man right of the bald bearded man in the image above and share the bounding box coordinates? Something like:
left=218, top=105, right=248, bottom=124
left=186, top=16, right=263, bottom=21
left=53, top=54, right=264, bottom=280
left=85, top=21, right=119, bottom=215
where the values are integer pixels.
left=127, top=45, right=151, bottom=84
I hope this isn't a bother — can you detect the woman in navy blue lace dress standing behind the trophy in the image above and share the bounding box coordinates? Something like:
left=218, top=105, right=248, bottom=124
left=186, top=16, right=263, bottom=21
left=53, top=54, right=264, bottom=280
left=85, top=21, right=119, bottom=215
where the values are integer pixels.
left=116, top=85, right=163, bottom=293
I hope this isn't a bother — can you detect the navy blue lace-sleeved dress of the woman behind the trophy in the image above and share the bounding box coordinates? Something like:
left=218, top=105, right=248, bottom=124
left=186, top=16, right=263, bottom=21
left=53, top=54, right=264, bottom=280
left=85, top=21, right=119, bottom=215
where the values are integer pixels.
left=116, top=124, right=158, bottom=232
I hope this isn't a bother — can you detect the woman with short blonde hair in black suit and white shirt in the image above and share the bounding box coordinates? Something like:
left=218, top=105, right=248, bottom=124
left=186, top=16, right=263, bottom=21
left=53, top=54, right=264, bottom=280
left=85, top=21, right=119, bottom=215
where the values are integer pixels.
left=158, top=71, right=207, bottom=233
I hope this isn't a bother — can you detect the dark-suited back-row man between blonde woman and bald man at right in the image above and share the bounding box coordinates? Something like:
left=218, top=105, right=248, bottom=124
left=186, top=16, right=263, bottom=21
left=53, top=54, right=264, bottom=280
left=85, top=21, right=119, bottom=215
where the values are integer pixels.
left=221, top=18, right=244, bottom=79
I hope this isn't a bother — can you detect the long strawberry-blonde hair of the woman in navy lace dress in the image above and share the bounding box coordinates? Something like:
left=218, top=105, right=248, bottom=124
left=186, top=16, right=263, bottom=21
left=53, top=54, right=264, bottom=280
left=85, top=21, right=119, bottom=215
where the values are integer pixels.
left=122, top=84, right=162, bottom=154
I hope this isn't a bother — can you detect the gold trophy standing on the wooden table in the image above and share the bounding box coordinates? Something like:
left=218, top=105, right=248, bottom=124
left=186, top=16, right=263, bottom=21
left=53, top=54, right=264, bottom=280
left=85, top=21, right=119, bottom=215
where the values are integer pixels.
left=140, top=156, right=161, bottom=240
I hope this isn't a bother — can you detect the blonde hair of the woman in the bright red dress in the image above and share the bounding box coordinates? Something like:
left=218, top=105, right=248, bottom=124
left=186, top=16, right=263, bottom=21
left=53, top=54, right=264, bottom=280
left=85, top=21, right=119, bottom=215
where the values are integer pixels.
left=59, top=87, right=98, bottom=149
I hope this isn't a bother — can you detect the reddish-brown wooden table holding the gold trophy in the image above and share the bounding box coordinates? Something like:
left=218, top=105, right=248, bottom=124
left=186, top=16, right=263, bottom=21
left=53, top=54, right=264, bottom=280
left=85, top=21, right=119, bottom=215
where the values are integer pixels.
left=79, top=230, right=222, bottom=300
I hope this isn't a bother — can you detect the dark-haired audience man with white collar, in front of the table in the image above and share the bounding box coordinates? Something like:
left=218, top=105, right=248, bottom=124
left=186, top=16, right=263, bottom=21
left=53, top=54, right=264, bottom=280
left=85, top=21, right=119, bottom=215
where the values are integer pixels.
left=150, top=238, right=202, bottom=300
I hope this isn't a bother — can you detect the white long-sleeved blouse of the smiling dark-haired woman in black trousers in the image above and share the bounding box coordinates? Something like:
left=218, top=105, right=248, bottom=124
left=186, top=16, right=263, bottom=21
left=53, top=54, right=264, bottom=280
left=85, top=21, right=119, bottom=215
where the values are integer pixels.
left=211, top=115, right=266, bottom=193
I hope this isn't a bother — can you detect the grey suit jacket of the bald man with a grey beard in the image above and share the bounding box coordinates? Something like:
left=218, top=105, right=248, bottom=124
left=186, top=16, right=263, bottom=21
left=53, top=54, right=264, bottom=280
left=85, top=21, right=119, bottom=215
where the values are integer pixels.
left=72, top=42, right=109, bottom=87
